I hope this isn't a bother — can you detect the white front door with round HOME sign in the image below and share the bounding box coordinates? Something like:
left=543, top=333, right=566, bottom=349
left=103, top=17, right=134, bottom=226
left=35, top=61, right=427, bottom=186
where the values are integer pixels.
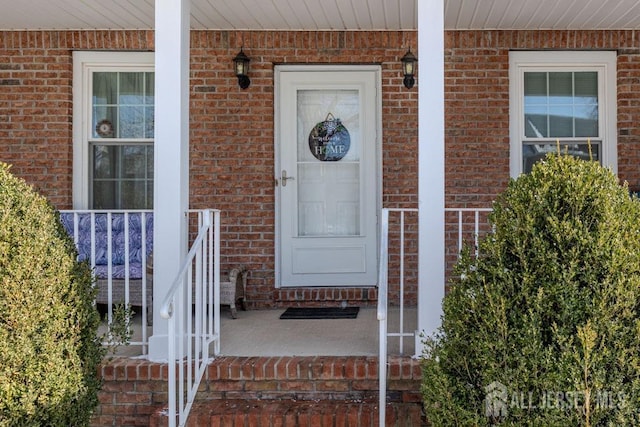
left=275, top=65, right=381, bottom=287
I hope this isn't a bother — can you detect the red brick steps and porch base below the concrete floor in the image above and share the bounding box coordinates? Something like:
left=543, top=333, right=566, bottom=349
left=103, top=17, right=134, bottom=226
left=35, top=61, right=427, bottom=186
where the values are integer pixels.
left=91, top=356, right=422, bottom=427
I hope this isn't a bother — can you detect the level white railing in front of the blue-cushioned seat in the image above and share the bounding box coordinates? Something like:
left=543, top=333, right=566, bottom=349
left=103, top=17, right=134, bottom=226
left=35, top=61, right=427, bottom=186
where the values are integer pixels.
left=60, top=210, right=153, bottom=354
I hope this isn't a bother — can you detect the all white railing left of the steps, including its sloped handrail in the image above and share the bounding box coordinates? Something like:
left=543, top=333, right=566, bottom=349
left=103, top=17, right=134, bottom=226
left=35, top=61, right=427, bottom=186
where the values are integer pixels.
left=60, top=210, right=220, bottom=427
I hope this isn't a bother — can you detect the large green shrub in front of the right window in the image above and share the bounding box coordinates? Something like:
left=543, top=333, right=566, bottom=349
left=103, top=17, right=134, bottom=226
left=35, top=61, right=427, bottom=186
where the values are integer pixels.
left=422, top=155, right=640, bottom=426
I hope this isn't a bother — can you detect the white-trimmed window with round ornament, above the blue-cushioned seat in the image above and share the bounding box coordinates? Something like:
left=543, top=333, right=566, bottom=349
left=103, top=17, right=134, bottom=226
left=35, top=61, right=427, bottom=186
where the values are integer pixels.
left=73, top=52, right=155, bottom=209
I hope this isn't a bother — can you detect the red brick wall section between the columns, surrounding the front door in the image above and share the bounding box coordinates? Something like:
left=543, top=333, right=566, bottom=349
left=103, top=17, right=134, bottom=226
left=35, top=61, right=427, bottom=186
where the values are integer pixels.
left=186, top=31, right=417, bottom=307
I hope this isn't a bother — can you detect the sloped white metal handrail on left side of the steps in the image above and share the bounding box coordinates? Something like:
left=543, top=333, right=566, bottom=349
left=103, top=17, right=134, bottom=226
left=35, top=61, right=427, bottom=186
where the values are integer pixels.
left=160, top=210, right=220, bottom=427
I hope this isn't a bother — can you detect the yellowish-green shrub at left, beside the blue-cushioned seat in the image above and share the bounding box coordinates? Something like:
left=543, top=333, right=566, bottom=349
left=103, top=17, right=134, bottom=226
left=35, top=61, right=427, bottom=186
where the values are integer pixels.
left=0, top=164, right=104, bottom=426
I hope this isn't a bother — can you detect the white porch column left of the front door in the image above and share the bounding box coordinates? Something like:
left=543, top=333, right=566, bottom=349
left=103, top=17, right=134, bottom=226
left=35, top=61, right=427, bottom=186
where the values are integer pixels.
left=149, top=0, right=191, bottom=361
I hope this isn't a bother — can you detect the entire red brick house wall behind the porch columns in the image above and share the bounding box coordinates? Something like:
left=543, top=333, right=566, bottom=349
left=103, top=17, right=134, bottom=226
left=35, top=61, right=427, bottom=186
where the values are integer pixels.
left=0, top=31, right=640, bottom=307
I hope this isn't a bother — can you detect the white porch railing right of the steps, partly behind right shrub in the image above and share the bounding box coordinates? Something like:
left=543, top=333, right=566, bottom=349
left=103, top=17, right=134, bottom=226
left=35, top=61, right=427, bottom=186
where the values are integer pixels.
left=377, top=208, right=491, bottom=427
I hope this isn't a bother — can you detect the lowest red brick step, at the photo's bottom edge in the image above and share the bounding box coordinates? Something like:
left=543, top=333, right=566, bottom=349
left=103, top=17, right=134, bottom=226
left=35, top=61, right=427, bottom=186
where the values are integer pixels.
left=150, top=400, right=426, bottom=427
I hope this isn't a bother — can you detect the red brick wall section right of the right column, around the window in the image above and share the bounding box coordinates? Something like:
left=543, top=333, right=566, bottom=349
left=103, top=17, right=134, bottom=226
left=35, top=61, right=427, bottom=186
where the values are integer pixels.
left=445, top=31, right=640, bottom=207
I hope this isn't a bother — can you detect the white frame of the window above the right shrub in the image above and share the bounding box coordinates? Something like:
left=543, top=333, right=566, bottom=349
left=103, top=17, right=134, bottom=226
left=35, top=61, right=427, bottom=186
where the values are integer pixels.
left=509, top=51, right=618, bottom=178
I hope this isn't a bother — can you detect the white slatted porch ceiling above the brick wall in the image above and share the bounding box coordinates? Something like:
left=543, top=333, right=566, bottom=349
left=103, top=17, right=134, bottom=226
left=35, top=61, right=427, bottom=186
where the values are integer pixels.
left=0, top=0, right=640, bottom=30
